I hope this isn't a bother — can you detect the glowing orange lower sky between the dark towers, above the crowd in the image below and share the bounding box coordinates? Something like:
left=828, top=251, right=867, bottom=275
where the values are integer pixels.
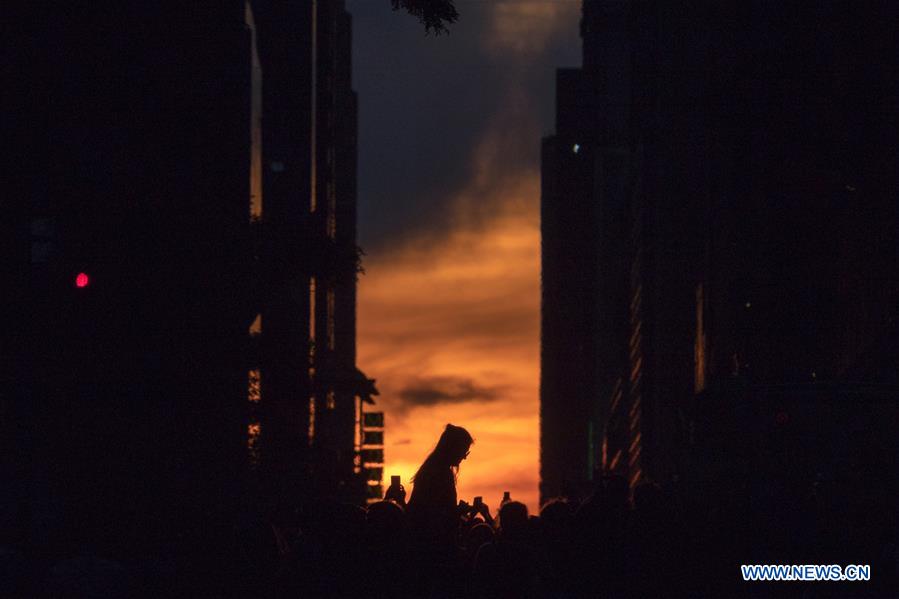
left=359, top=178, right=540, bottom=511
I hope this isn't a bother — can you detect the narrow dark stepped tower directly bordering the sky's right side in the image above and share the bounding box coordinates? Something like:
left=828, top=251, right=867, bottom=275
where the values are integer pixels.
left=540, top=2, right=642, bottom=499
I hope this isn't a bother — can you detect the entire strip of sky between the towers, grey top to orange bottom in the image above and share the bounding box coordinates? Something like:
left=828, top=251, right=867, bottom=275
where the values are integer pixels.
left=347, top=0, right=581, bottom=510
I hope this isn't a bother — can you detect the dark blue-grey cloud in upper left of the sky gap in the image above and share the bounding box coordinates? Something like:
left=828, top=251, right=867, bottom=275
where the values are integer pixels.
left=347, top=0, right=501, bottom=250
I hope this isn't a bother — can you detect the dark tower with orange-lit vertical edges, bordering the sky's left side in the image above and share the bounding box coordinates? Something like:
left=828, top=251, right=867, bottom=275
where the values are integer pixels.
left=248, top=1, right=376, bottom=506
